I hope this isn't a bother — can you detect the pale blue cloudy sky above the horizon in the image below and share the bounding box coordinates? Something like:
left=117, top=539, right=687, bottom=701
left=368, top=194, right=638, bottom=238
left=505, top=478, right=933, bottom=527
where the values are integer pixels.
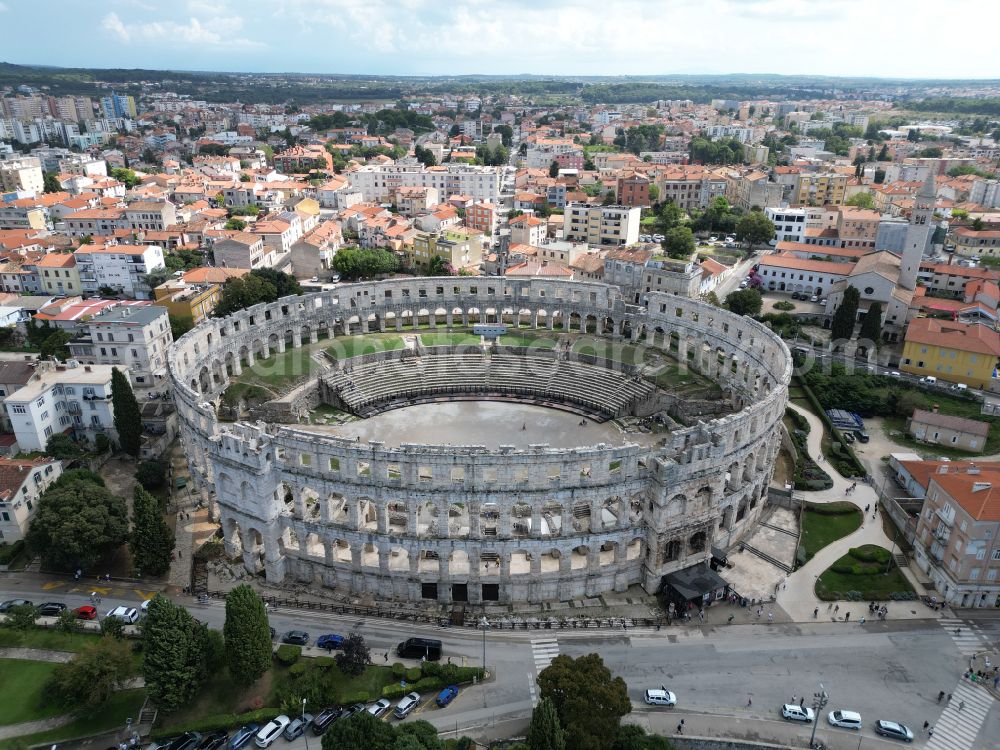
left=0, top=0, right=1000, bottom=78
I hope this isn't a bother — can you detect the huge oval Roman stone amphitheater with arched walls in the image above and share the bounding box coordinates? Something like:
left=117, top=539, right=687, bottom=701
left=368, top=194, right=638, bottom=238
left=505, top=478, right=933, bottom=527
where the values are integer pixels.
left=169, top=277, right=791, bottom=604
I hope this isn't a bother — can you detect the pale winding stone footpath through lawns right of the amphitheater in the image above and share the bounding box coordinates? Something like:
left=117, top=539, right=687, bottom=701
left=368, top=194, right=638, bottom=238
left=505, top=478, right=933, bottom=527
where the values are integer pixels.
left=777, top=403, right=947, bottom=622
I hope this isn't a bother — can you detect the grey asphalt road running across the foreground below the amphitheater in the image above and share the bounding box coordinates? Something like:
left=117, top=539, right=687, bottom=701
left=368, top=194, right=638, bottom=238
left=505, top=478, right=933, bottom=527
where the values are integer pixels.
left=0, top=576, right=1000, bottom=750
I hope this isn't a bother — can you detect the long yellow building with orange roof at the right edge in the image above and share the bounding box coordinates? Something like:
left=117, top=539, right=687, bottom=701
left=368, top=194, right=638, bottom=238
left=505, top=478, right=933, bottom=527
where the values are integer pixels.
left=899, top=318, right=1000, bottom=388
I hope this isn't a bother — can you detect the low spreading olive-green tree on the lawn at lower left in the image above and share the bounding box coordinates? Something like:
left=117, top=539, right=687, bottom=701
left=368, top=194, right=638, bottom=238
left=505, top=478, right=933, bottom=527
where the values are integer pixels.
left=45, top=636, right=135, bottom=709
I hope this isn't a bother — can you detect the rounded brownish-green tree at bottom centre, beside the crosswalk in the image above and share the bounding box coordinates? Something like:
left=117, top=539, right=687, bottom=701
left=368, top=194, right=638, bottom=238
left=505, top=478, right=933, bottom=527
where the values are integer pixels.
left=538, top=654, right=632, bottom=750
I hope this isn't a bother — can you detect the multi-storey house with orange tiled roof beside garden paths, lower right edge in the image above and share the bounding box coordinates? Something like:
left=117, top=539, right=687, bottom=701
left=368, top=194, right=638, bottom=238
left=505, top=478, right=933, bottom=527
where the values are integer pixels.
left=914, top=465, right=1000, bottom=607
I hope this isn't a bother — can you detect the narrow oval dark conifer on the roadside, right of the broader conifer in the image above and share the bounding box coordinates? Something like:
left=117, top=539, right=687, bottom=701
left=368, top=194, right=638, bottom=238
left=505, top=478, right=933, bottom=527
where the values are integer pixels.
left=222, top=583, right=271, bottom=685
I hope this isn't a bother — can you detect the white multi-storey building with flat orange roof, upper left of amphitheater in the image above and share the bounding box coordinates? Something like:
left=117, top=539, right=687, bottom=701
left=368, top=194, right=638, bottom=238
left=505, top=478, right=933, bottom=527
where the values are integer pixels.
left=75, top=245, right=164, bottom=299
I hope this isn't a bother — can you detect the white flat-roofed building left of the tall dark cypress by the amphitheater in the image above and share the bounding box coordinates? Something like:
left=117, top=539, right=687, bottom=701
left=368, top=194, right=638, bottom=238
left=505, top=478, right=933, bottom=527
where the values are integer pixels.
left=4, top=362, right=128, bottom=451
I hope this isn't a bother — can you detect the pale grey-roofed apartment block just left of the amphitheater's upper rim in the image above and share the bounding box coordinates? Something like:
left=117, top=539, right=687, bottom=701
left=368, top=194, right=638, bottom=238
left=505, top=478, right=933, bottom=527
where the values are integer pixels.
left=68, top=305, right=174, bottom=391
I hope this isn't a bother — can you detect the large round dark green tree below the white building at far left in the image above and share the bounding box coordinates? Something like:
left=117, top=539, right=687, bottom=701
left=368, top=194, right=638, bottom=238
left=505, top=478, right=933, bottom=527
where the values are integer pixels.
left=25, top=470, right=128, bottom=570
